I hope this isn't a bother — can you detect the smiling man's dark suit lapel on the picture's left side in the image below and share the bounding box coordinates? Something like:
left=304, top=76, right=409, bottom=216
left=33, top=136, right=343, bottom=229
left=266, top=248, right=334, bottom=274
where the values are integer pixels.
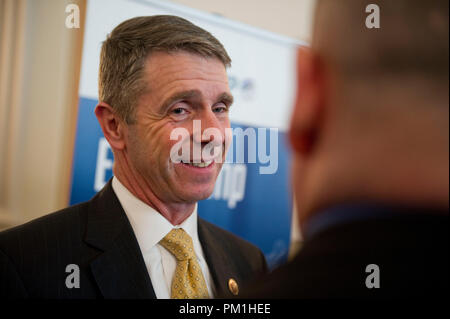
left=85, top=180, right=156, bottom=299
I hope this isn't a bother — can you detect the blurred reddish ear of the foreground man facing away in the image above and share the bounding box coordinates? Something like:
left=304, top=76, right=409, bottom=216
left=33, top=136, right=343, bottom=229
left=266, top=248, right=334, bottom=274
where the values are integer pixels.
left=289, top=47, right=324, bottom=156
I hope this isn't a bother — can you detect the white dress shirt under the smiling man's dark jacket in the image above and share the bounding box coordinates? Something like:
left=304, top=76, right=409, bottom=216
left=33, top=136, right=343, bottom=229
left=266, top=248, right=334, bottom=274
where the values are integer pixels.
left=112, top=177, right=213, bottom=299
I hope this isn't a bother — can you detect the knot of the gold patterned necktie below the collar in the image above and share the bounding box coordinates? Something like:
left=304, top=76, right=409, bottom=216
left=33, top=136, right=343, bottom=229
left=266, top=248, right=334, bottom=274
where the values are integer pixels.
left=159, top=228, right=195, bottom=260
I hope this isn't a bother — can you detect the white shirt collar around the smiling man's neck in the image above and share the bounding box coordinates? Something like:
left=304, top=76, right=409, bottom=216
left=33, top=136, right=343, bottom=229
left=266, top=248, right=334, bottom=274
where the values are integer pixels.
left=112, top=176, right=201, bottom=254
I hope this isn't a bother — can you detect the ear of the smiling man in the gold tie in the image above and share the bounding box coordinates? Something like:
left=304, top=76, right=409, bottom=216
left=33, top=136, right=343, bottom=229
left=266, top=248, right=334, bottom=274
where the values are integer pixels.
left=95, top=102, right=125, bottom=150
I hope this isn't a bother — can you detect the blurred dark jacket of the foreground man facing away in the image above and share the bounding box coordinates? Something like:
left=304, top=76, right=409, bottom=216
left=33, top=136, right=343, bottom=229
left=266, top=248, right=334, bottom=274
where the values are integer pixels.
left=240, top=206, right=449, bottom=298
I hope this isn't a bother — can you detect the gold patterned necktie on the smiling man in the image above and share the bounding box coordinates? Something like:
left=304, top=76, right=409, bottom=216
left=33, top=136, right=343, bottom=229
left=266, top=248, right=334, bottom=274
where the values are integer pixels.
left=159, top=228, right=209, bottom=299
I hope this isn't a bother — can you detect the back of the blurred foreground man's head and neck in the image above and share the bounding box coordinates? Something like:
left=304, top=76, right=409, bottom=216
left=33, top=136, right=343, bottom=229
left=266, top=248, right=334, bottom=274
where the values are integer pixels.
left=290, top=0, right=449, bottom=228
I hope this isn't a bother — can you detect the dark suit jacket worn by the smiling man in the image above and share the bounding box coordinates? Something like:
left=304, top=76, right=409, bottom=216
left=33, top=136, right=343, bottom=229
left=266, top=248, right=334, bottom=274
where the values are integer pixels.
left=0, top=181, right=266, bottom=298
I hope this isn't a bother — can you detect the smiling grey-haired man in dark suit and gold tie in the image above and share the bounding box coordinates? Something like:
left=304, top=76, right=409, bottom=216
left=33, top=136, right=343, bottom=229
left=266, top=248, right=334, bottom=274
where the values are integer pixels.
left=0, top=16, right=266, bottom=298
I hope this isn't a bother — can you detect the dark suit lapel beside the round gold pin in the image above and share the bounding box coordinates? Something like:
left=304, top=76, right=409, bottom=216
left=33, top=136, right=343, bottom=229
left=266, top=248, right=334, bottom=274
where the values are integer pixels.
left=198, top=218, right=238, bottom=298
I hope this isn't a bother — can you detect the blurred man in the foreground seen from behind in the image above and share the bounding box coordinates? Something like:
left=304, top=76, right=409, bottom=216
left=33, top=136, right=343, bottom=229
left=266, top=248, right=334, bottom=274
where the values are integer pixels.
left=241, top=0, right=449, bottom=298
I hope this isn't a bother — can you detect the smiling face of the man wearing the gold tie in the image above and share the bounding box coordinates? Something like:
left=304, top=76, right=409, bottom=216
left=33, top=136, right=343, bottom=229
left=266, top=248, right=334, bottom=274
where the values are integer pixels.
left=126, top=52, right=232, bottom=203
